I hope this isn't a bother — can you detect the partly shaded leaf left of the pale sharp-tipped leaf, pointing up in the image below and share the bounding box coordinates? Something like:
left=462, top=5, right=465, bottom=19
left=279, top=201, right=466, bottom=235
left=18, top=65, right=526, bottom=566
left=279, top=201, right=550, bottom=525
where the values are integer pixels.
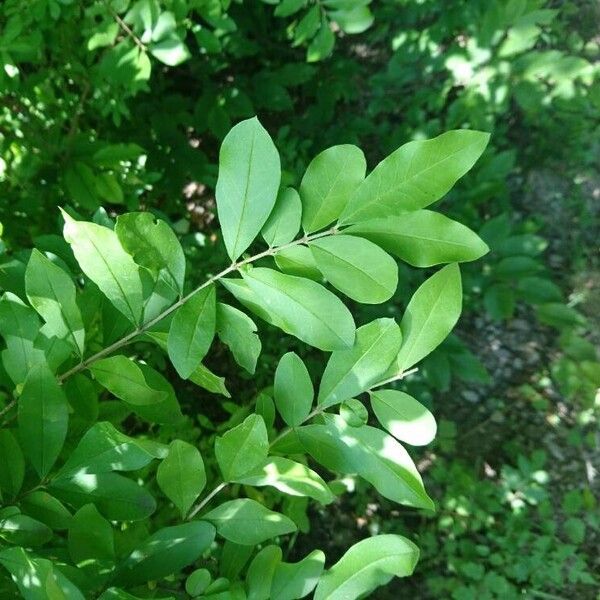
left=25, top=248, right=85, bottom=356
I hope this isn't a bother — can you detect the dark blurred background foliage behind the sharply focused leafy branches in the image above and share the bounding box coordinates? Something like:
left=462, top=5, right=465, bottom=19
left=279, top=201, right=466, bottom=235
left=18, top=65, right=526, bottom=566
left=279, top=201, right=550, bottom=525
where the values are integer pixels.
left=0, top=0, right=600, bottom=600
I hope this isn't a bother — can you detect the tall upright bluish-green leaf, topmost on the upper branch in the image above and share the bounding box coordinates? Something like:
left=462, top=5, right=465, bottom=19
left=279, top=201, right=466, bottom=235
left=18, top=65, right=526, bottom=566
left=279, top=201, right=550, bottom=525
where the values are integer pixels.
left=216, top=117, right=281, bottom=260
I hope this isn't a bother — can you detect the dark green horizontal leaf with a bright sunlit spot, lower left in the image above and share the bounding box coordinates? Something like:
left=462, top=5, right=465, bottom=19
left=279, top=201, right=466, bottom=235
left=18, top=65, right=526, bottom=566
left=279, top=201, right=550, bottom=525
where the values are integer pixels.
left=50, top=473, right=156, bottom=521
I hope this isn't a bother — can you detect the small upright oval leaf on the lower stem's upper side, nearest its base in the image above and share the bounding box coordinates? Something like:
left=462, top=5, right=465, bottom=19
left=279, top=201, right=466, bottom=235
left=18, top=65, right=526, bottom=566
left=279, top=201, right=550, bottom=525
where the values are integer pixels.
left=274, top=352, right=315, bottom=427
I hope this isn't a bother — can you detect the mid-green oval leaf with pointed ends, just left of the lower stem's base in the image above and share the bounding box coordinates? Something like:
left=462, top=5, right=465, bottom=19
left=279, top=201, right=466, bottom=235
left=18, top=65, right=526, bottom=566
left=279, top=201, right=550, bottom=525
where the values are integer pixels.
left=156, top=440, right=206, bottom=518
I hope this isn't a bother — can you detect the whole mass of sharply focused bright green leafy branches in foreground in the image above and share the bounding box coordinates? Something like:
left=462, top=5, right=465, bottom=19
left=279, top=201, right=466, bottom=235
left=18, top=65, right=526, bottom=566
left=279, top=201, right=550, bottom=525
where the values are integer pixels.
left=0, top=118, right=488, bottom=600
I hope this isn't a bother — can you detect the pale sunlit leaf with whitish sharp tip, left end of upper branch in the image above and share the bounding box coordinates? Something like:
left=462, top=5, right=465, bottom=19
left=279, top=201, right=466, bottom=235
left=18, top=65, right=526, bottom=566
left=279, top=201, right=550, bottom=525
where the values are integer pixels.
left=62, top=211, right=143, bottom=324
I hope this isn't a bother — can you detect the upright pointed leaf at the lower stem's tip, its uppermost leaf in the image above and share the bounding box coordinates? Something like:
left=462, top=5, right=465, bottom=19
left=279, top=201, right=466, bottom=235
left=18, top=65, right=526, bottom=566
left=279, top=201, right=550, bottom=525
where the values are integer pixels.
left=396, top=263, right=462, bottom=373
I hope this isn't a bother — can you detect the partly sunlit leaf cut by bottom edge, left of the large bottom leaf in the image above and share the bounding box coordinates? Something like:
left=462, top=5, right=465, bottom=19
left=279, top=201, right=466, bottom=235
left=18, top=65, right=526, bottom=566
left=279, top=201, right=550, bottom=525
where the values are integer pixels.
left=271, top=550, right=325, bottom=600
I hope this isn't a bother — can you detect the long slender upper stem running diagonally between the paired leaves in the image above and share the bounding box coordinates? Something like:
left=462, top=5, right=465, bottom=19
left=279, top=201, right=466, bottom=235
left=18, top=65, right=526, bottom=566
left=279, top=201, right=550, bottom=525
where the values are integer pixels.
left=58, top=227, right=338, bottom=383
